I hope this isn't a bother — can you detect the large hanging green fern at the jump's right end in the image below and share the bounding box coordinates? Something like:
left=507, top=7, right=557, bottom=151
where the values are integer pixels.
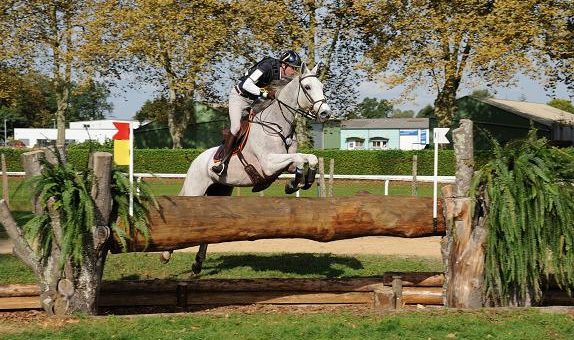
left=470, top=130, right=574, bottom=306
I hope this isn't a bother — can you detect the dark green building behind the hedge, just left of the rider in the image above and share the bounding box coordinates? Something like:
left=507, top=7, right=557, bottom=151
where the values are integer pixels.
left=134, top=103, right=229, bottom=149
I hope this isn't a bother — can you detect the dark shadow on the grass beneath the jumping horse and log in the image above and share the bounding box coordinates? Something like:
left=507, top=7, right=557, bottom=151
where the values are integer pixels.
left=195, top=253, right=363, bottom=278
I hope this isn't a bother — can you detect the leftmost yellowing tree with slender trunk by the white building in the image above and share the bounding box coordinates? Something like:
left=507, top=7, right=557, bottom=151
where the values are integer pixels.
left=0, top=0, right=113, bottom=149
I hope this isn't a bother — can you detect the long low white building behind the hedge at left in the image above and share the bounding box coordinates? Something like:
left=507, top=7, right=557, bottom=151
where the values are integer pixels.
left=14, top=119, right=140, bottom=148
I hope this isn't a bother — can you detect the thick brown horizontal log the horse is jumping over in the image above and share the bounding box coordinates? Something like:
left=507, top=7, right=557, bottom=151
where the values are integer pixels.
left=113, top=195, right=444, bottom=252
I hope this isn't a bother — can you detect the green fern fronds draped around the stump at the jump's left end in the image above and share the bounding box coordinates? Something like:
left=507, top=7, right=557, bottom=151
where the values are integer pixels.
left=24, top=153, right=157, bottom=268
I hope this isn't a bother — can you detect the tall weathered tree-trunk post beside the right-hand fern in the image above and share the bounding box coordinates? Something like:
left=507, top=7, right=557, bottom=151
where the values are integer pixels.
left=443, top=119, right=486, bottom=308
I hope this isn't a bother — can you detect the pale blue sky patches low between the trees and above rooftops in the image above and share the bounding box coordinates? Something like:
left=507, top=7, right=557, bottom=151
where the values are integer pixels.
left=108, top=77, right=574, bottom=120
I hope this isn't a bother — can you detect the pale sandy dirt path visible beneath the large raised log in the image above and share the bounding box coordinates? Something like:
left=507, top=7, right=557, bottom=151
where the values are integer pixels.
left=0, top=236, right=441, bottom=257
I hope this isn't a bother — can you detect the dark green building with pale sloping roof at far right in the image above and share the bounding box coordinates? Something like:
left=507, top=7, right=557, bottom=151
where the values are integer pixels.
left=457, top=96, right=574, bottom=149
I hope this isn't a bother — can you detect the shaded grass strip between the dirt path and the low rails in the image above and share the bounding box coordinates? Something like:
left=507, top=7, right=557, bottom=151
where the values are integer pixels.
left=0, top=252, right=443, bottom=285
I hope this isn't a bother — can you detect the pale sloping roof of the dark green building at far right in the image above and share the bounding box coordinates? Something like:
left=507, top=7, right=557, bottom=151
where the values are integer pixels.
left=472, top=97, right=574, bottom=126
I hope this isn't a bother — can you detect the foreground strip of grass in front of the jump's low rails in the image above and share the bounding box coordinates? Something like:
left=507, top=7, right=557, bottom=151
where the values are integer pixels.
left=0, top=310, right=574, bottom=340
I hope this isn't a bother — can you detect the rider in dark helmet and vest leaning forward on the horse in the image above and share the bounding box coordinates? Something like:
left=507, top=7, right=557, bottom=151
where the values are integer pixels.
left=211, top=50, right=301, bottom=176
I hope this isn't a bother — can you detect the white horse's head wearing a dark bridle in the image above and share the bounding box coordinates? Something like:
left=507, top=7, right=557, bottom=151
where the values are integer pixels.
left=297, top=64, right=331, bottom=123
